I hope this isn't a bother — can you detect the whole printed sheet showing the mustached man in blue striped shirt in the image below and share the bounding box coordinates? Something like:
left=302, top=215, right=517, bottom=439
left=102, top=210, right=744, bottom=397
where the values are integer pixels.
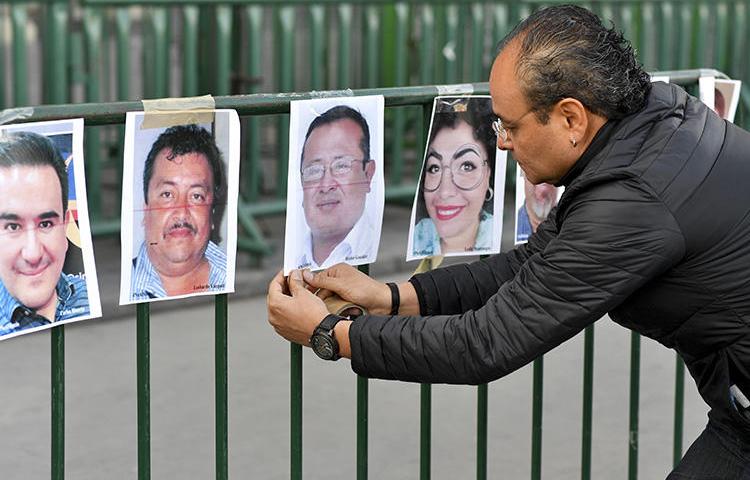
left=120, top=110, right=240, bottom=305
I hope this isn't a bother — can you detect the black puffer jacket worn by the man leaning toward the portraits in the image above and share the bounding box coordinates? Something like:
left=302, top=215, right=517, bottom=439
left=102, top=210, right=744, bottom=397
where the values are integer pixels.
left=350, top=83, right=750, bottom=432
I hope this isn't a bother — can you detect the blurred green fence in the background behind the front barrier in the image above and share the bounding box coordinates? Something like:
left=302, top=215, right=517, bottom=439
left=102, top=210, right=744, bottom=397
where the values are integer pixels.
left=0, top=0, right=750, bottom=255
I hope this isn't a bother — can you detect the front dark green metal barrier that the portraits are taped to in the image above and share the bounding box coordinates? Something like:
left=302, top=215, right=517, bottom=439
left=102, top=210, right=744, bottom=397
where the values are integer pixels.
left=4, top=70, right=724, bottom=480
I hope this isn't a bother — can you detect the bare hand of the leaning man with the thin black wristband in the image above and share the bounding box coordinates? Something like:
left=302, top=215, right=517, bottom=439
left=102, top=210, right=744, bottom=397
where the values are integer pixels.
left=303, top=263, right=391, bottom=315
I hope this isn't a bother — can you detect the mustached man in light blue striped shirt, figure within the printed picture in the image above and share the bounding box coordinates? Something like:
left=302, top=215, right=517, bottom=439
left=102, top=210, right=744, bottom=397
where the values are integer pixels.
left=131, top=125, right=227, bottom=301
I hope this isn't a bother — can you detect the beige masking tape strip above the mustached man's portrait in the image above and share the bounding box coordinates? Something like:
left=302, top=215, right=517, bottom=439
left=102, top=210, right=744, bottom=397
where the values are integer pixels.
left=141, top=95, right=216, bottom=130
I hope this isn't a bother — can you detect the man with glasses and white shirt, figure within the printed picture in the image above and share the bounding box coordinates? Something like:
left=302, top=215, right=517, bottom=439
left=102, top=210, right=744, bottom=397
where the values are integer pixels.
left=287, top=97, right=382, bottom=270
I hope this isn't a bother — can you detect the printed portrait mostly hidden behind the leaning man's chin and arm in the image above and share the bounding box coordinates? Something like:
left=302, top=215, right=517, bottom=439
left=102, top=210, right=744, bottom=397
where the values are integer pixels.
left=515, top=166, right=564, bottom=245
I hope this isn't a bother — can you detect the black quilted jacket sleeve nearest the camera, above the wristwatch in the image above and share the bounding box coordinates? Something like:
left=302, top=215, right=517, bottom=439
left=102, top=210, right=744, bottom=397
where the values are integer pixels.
left=349, top=179, right=685, bottom=384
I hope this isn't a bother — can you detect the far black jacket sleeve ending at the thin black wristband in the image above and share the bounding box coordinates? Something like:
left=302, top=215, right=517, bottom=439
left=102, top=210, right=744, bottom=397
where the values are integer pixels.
left=409, top=209, right=557, bottom=315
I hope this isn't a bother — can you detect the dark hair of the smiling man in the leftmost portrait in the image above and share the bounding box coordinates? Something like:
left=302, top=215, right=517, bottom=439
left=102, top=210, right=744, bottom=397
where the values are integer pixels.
left=0, top=132, right=68, bottom=213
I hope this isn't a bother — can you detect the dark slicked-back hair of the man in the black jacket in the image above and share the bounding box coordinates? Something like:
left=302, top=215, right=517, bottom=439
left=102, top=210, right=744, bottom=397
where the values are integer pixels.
left=498, top=5, right=651, bottom=123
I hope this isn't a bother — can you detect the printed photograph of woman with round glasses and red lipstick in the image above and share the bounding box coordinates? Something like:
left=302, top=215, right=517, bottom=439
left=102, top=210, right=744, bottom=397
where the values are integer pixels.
left=406, top=96, right=506, bottom=260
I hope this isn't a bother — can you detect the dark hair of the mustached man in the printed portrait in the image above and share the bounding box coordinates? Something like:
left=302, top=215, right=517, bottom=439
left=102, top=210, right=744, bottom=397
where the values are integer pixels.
left=143, top=124, right=227, bottom=242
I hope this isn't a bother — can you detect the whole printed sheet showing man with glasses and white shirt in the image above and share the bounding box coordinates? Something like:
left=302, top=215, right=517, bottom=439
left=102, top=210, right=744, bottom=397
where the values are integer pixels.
left=284, top=95, right=385, bottom=275
